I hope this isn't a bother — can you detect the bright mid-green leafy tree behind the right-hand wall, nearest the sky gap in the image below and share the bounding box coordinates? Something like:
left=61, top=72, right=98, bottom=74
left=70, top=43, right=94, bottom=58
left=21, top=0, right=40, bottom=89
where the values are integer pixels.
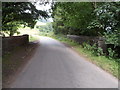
left=53, top=2, right=94, bottom=35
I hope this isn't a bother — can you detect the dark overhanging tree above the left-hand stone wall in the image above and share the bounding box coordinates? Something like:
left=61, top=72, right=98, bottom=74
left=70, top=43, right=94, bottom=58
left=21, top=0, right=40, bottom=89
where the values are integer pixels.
left=2, top=2, right=49, bottom=36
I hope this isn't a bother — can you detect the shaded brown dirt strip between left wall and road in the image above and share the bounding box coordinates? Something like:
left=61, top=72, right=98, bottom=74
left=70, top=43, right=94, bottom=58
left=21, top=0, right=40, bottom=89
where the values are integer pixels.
left=2, top=41, right=38, bottom=88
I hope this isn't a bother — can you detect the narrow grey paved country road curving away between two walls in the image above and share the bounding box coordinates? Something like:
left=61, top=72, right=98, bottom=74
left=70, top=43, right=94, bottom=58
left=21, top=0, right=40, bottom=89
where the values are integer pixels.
left=11, top=37, right=118, bottom=88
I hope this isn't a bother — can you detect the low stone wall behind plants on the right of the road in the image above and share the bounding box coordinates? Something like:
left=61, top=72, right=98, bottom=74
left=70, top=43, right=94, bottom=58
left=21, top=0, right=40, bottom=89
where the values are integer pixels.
left=67, top=35, right=107, bottom=52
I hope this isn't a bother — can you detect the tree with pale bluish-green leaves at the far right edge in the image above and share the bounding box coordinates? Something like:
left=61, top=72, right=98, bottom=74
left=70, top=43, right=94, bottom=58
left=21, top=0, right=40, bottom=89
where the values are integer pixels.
left=93, top=2, right=120, bottom=46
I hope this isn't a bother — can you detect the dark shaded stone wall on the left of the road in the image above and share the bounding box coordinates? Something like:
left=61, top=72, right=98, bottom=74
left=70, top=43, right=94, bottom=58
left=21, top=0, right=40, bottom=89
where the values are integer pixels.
left=2, top=35, right=29, bottom=55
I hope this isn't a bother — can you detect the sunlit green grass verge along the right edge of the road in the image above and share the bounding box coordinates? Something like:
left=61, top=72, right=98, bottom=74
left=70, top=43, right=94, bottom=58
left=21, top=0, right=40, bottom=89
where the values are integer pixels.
left=50, top=35, right=120, bottom=79
